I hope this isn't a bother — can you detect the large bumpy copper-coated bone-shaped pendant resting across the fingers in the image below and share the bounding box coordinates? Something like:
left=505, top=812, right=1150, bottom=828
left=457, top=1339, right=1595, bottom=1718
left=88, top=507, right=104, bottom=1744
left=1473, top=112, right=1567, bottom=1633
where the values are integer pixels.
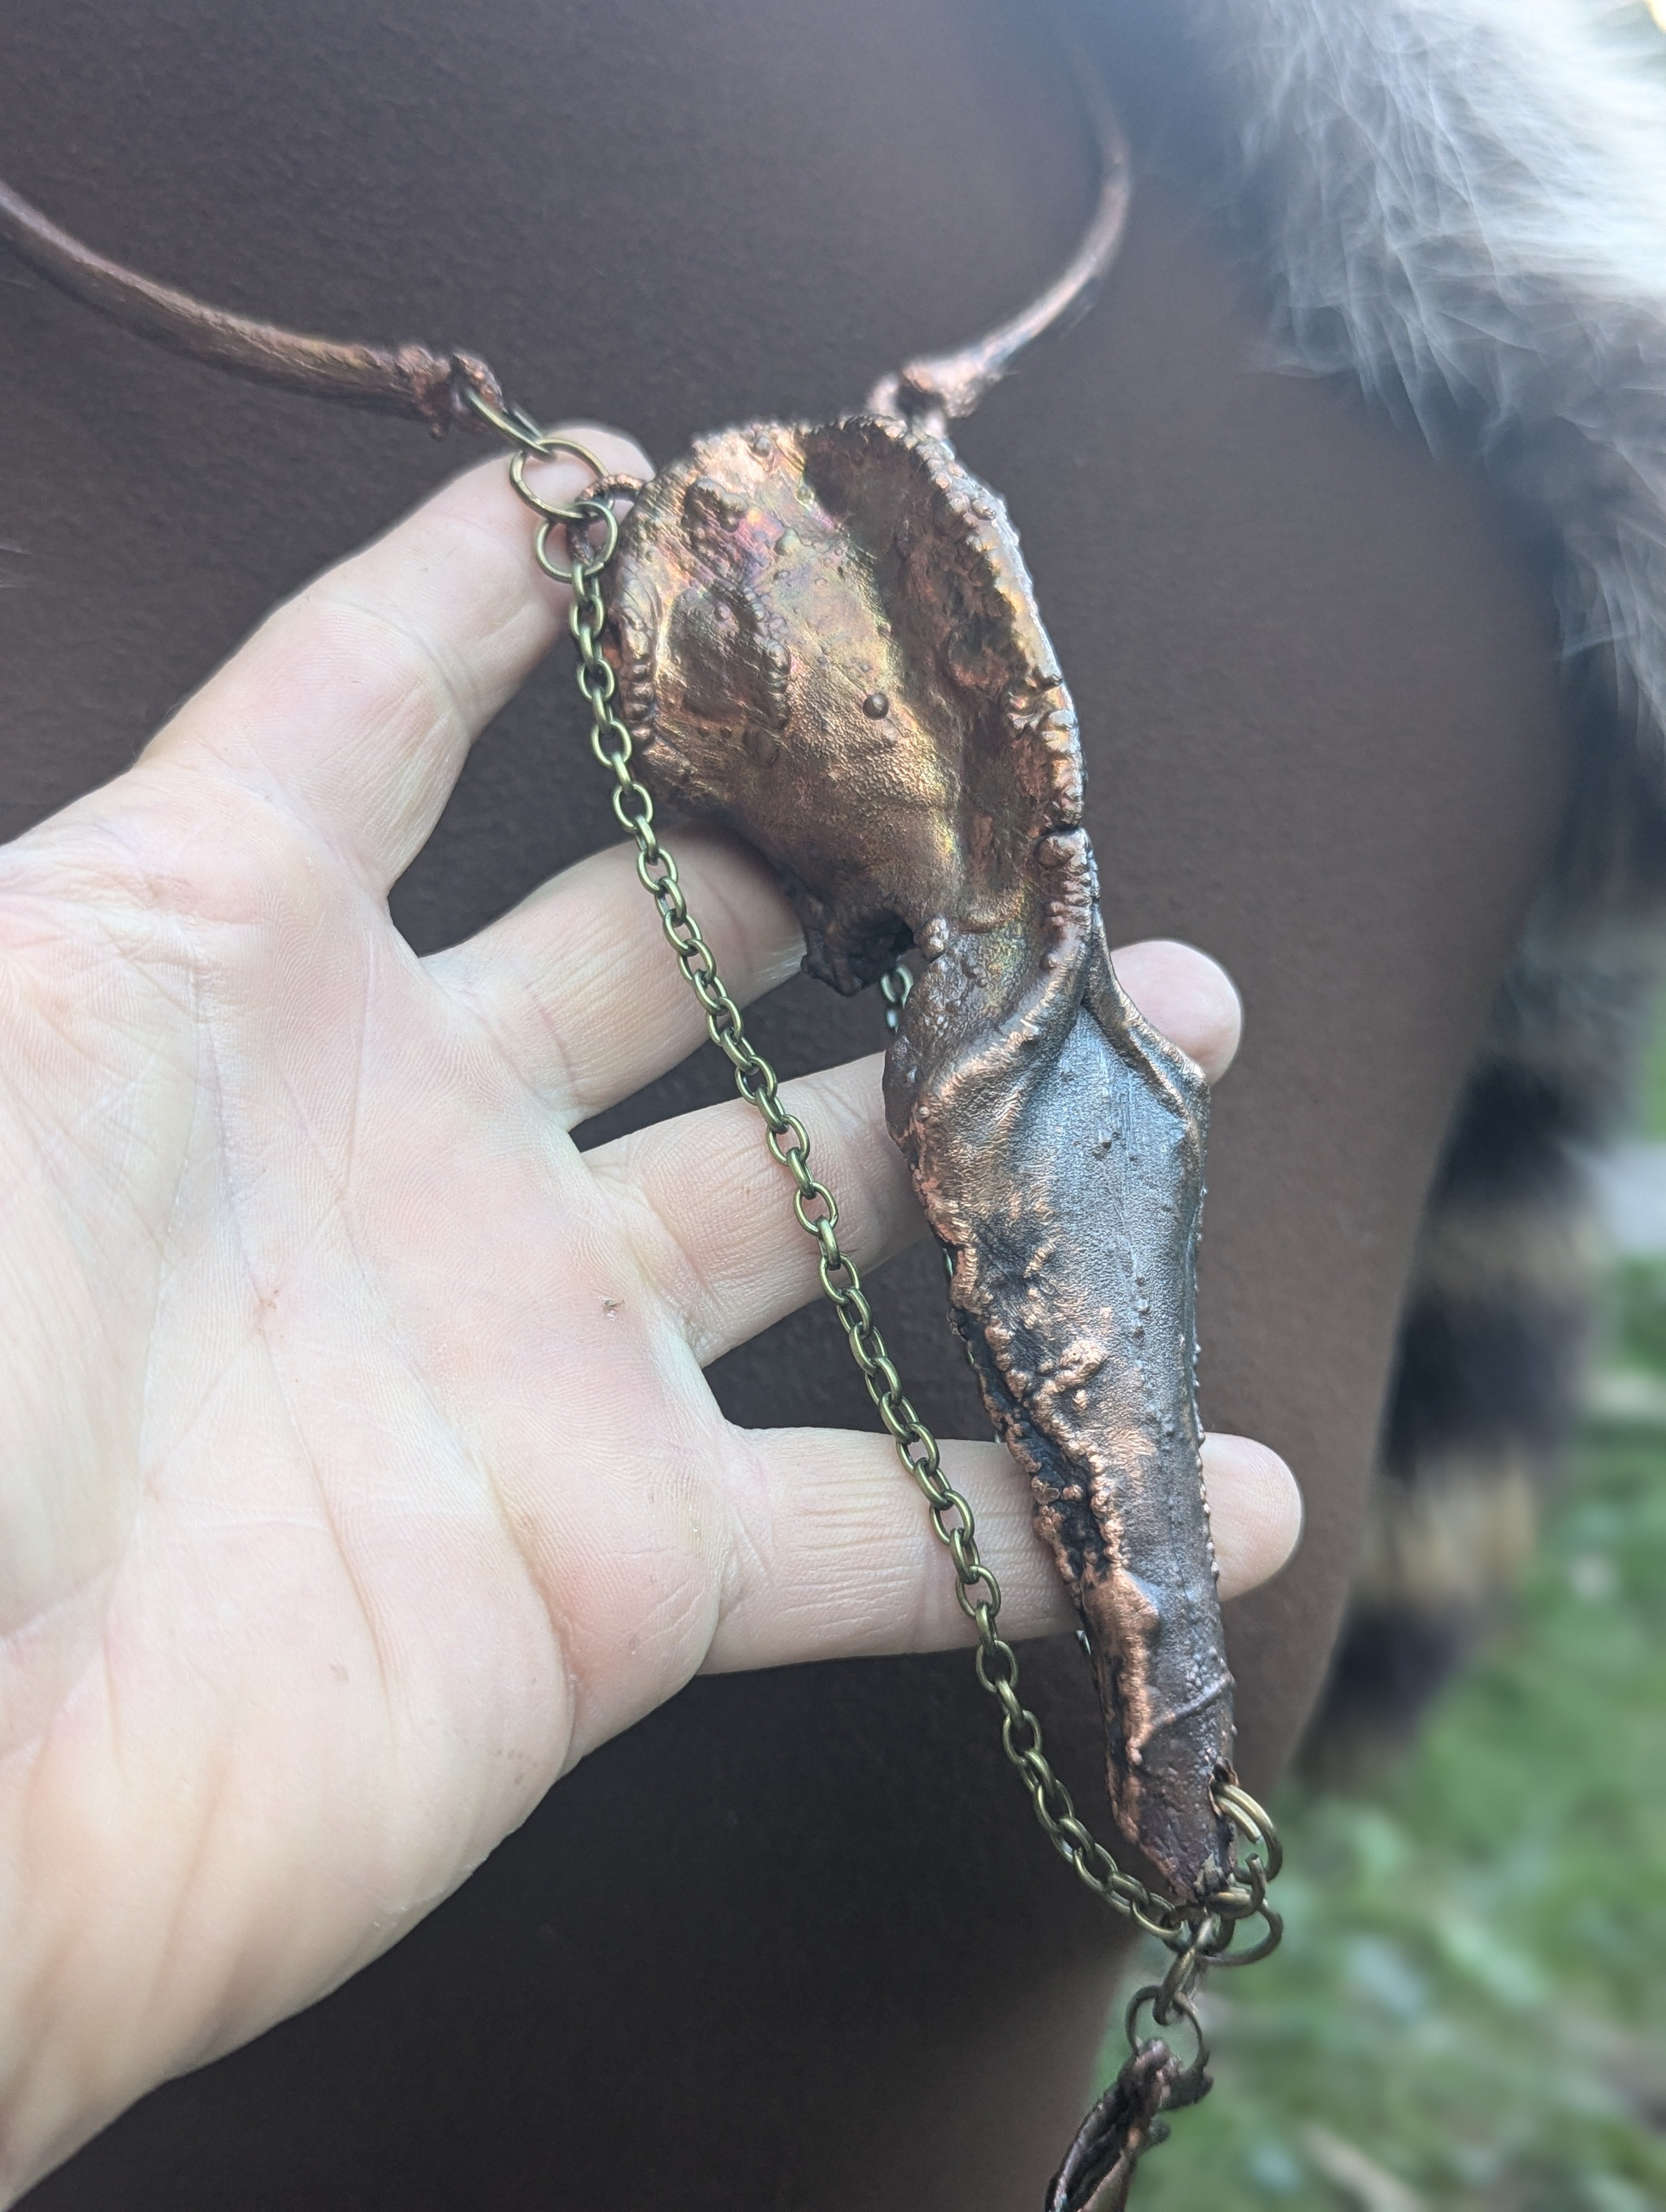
left=611, top=416, right=1232, bottom=1898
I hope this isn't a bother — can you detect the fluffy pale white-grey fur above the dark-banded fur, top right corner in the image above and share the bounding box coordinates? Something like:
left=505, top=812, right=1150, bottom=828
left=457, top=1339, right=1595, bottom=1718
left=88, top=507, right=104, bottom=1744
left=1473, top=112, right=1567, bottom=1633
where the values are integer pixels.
left=1186, top=0, right=1666, bottom=758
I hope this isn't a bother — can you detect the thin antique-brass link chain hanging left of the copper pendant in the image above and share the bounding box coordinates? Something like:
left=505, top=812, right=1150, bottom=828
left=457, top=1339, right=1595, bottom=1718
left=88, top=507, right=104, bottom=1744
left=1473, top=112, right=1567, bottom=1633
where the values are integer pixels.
left=540, top=487, right=1281, bottom=1973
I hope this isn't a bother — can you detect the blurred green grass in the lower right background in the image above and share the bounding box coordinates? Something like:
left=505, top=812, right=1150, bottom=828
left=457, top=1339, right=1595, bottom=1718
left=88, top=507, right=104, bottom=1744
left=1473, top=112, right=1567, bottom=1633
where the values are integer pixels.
left=1111, top=1268, right=1666, bottom=2212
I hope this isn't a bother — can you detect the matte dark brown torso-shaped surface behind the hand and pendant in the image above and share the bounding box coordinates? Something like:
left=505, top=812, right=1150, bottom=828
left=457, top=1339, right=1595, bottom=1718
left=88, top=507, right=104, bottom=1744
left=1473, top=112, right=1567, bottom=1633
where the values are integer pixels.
left=0, top=0, right=1562, bottom=2212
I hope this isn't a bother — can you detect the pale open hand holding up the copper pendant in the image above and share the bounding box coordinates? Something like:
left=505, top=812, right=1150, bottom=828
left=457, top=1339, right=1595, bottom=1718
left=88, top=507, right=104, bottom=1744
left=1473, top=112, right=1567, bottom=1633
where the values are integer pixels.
left=0, top=432, right=1299, bottom=2194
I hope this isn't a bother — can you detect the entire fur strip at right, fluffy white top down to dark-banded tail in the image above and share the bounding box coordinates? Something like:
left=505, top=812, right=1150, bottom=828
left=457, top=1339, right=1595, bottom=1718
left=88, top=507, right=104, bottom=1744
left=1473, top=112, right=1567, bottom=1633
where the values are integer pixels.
left=1150, top=0, right=1666, bottom=1741
